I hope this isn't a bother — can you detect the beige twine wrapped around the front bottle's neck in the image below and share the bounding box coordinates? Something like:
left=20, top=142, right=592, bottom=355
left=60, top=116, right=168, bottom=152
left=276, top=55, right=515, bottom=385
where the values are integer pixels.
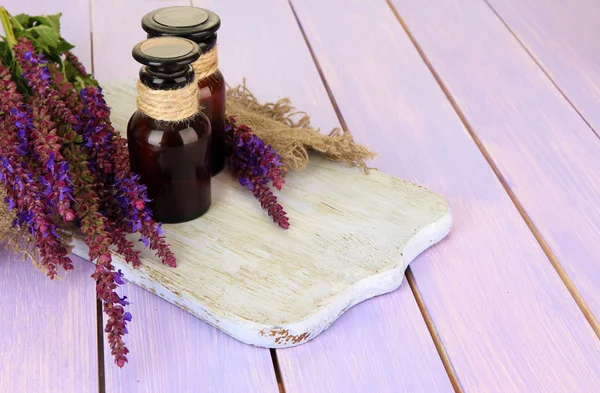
left=136, top=78, right=200, bottom=121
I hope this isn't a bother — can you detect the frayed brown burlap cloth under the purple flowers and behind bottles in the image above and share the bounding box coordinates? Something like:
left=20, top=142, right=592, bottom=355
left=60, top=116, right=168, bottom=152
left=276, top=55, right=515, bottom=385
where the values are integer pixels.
left=0, top=83, right=375, bottom=271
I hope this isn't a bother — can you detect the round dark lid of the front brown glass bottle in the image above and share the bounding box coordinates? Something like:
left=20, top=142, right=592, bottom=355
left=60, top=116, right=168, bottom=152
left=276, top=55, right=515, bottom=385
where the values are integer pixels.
left=131, top=37, right=200, bottom=69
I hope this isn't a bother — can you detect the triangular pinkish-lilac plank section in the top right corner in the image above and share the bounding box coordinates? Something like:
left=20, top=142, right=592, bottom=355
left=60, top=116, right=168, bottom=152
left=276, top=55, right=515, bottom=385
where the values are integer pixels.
left=487, top=0, right=600, bottom=134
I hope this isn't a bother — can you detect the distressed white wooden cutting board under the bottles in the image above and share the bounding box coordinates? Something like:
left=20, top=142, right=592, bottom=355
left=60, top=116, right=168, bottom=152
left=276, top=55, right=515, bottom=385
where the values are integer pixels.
left=69, top=84, right=452, bottom=348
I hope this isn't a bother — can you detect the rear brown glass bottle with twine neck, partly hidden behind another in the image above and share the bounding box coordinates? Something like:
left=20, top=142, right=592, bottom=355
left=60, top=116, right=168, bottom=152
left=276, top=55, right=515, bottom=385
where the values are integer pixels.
left=142, top=6, right=226, bottom=175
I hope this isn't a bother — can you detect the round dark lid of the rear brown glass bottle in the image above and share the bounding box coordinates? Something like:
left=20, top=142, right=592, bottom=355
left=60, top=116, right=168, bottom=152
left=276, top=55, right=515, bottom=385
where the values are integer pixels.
left=142, top=6, right=221, bottom=43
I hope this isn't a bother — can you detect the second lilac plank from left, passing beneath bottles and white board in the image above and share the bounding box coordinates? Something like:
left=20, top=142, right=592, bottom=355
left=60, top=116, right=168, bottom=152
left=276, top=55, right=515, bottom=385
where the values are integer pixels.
left=92, top=0, right=278, bottom=393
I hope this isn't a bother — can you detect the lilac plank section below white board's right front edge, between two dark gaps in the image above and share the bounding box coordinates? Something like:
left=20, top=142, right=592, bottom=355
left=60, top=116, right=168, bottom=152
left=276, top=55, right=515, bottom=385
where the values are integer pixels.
left=277, top=282, right=454, bottom=393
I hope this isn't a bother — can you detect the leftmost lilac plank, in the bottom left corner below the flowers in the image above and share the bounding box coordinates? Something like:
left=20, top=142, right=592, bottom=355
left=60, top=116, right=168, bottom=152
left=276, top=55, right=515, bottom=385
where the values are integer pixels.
left=0, top=251, right=98, bottom=393
